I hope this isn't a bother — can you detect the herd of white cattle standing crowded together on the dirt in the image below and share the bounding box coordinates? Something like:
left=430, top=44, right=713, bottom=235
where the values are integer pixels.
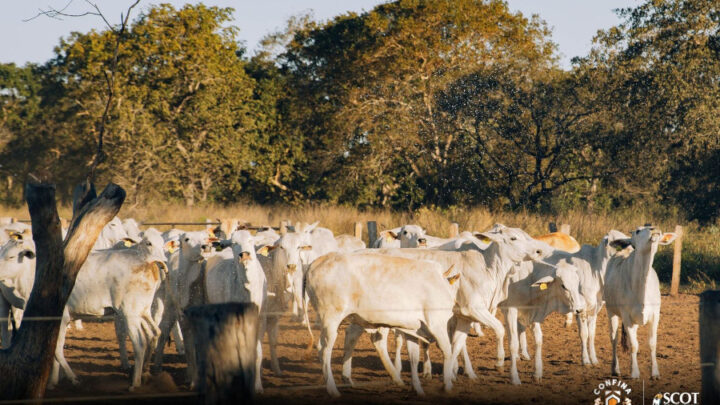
left=0, top=218, right=675, bottom=396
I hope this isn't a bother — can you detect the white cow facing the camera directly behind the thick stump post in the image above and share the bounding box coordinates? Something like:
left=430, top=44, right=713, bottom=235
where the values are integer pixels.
left=205, top=230, right=268, bottom=392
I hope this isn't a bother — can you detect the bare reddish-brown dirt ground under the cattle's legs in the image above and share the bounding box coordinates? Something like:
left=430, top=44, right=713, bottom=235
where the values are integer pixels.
left=42, top=295, right=700, bottom=404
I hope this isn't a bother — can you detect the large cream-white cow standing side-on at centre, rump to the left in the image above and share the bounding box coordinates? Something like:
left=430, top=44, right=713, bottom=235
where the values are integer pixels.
left=305, top=253, right=455, bottom=397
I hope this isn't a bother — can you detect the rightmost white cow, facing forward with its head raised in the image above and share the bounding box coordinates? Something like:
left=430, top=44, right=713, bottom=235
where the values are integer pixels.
left=604, top=226, right=677, bottom=379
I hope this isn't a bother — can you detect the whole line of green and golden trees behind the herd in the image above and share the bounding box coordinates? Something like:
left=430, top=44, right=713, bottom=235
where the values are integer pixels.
left=0, top=0, right=720, bottom=221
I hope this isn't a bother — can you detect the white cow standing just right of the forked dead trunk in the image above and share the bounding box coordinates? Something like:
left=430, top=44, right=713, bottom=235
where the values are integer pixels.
left=49, top=235, right=167, bottom=390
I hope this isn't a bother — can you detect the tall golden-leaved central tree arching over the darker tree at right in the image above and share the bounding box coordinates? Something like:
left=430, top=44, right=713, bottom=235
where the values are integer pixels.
left=280, top=0, right=554, bottom=206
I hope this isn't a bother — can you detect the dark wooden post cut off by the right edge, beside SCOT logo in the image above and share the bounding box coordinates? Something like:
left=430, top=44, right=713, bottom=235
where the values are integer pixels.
left=699, top=291, right=720, bottom=404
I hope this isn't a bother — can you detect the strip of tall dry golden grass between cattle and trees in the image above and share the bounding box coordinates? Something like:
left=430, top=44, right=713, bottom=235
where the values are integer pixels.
left=0, top=204, right=720, bottom=291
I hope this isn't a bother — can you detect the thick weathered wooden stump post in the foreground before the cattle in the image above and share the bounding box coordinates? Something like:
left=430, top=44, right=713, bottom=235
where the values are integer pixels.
left=185, top=302, right=258, bottom=404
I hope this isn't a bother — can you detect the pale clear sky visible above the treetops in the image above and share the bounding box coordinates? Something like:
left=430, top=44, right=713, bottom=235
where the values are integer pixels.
left=0, top=0, right=640, bottom=68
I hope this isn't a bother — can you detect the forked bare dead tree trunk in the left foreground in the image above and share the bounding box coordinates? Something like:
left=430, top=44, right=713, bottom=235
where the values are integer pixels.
left=0, top=183, right=125, bottom=399
